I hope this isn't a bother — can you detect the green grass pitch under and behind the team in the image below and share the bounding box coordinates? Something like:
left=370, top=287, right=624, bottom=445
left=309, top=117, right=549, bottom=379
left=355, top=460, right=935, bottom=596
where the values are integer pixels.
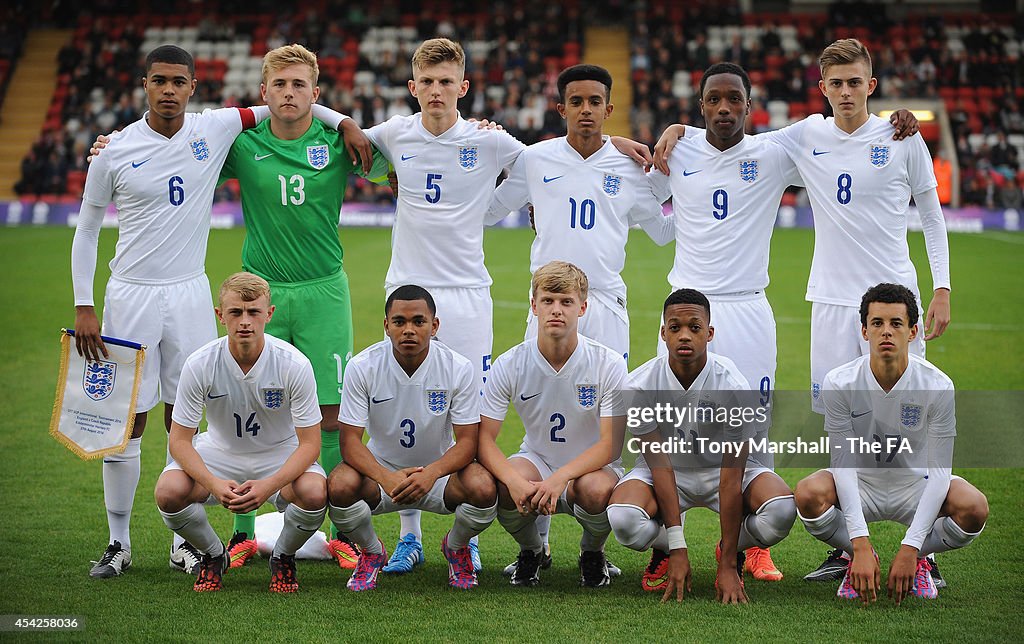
left=0, top=227, right=1024, bottom=642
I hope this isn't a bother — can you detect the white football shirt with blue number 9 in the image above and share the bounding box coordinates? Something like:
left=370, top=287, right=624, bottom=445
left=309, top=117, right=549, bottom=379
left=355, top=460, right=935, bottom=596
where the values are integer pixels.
left=647, top=134, right=802, bottom=295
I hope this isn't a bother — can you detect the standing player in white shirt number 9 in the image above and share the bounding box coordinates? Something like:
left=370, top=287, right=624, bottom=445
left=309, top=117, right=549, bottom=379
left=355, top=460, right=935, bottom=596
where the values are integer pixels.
left=648, top=62, right=801, bottom=582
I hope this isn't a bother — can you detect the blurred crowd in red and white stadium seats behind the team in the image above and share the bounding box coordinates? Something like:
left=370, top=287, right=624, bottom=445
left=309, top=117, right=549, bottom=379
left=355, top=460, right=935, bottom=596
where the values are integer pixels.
left=12, top=0, right=1024, bottom=208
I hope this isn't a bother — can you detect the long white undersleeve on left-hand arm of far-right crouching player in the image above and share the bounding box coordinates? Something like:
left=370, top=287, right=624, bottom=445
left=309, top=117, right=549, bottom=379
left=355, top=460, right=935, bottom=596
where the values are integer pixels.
left=821, top=376, right=868, bottom=539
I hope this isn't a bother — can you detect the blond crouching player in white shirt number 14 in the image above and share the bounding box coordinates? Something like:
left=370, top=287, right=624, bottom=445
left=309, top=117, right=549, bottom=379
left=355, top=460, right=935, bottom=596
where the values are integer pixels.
left=156, top=272, right=327, bottom=593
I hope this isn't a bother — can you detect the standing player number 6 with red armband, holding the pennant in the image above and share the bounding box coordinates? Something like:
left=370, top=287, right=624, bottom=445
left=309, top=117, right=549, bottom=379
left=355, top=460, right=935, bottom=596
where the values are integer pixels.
left=71, top=45, right=266, bottom=577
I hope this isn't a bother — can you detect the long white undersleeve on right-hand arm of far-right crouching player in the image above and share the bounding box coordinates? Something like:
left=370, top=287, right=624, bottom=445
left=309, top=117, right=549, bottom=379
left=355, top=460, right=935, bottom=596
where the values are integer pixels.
left=902, top=387, right=956, bottom=550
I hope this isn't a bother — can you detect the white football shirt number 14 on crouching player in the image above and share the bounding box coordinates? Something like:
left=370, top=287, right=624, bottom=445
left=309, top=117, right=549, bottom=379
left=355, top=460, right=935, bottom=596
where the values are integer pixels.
left=172, top=335, right=323, bottom=454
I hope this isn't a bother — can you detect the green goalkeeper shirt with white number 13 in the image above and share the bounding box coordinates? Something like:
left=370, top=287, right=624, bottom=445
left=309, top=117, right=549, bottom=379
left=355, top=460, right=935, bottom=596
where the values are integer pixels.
left=220, top=119, right=390, bottom=282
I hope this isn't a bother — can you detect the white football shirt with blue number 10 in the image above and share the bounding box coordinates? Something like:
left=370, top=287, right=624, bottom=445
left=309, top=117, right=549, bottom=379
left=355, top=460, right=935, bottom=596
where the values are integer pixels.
left=487, top=136, right=674, bottom=300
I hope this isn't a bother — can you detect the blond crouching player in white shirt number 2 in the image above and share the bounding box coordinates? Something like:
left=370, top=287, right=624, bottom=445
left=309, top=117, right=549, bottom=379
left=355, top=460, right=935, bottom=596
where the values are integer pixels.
left=478, top=261, right=626, bottom=588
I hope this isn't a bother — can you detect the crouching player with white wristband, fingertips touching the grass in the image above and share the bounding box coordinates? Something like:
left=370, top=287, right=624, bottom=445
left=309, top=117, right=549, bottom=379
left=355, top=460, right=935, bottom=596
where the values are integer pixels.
left=608, top=289, right=797, bottom=603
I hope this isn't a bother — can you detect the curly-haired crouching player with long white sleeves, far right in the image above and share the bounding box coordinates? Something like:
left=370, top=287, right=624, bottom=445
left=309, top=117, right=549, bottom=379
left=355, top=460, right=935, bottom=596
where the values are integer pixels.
left=797, top=284, right=988, bottom=604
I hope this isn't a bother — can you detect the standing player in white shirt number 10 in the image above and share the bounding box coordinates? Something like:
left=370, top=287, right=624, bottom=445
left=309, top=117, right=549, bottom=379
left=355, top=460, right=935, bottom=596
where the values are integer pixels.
left=487, top=65, right=674, bottom=358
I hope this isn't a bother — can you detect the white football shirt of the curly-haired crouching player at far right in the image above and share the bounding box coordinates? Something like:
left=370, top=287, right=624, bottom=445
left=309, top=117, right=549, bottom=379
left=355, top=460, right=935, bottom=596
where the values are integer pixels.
left=821, top=353, right=956, bottom=479
